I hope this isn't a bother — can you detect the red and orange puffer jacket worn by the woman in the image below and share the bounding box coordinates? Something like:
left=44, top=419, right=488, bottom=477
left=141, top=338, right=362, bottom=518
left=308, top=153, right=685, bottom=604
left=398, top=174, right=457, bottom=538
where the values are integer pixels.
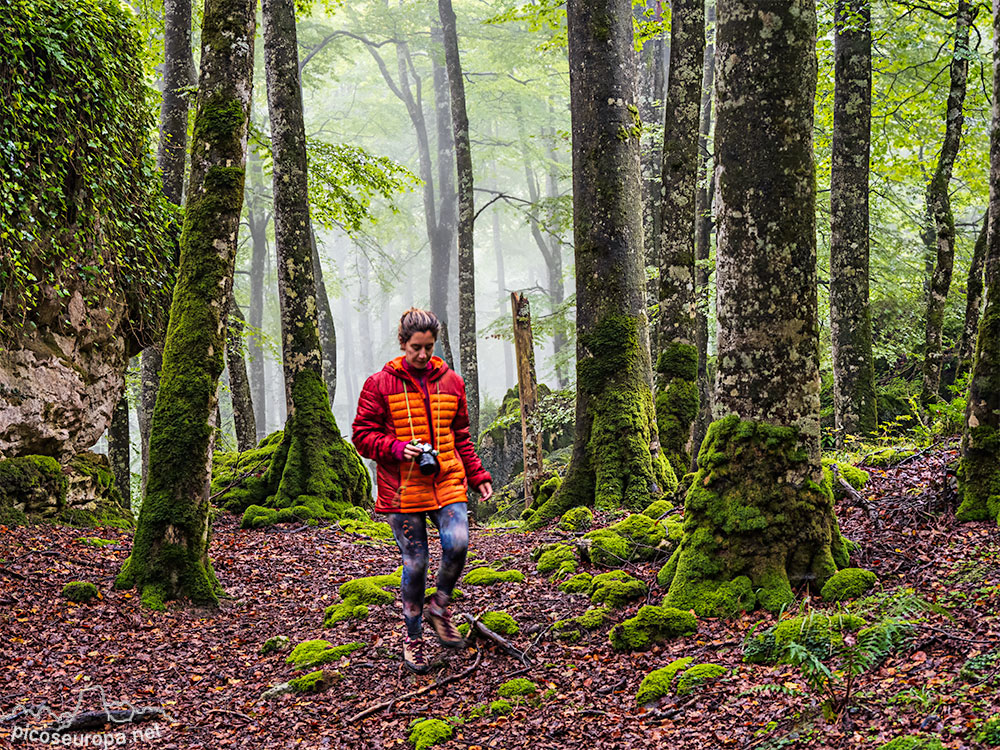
left=351, top=357, right=491, bottom=513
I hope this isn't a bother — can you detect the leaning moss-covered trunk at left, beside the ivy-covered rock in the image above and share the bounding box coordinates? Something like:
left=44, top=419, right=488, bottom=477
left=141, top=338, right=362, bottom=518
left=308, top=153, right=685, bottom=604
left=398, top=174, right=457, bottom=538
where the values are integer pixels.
left=116, top=0, right=255, bottom=608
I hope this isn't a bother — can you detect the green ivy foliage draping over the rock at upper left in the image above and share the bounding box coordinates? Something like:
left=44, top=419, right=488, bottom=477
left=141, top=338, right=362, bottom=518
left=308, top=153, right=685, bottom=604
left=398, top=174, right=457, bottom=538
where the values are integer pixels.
left=0, top=0, right=174, bottom=341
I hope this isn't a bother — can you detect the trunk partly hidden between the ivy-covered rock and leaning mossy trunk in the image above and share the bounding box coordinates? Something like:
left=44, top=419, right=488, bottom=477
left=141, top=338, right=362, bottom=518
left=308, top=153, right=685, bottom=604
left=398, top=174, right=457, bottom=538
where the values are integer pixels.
left=137, top=0, right=195, bottom=492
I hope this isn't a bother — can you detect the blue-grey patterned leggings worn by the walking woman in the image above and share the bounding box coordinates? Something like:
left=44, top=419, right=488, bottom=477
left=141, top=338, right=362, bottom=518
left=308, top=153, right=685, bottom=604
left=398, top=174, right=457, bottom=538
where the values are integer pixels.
left=386, top=503, right=469, bottom=639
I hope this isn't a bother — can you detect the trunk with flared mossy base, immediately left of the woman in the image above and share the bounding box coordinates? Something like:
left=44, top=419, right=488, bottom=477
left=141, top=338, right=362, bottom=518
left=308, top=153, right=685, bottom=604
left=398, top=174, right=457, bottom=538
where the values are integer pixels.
left=262, top=0, right=371, bottom=519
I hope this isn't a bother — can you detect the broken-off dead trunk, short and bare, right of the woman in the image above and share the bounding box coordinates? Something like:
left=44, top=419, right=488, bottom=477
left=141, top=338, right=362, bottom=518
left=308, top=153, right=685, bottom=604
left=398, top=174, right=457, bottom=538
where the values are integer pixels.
left=510, top=292, right=542, bottom=508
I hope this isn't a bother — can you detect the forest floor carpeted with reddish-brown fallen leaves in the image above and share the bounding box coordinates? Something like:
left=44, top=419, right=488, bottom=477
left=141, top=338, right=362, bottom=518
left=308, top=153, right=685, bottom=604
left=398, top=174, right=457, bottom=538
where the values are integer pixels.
left=0, top=449, right=1000, bottom=750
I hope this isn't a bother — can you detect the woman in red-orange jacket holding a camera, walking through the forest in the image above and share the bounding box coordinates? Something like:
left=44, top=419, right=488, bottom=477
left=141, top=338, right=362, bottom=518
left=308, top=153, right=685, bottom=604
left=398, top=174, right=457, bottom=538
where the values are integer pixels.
left=352, top=308, right=493, bottom=674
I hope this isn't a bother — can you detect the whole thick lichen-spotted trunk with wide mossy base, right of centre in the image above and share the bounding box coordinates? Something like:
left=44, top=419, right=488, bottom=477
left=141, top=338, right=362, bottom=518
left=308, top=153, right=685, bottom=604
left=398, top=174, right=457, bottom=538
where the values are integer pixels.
left=662, top=0, right=846, bottom=615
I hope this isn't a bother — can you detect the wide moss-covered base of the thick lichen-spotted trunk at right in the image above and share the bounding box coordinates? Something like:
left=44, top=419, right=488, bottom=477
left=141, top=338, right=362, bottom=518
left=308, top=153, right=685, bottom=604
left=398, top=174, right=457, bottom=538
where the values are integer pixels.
left=660, top=415, right=846, bottom=617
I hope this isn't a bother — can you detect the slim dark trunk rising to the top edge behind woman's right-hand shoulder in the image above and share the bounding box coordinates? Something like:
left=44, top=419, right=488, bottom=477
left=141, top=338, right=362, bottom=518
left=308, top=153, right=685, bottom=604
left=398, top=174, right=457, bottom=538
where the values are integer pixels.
left=438, top=0, right=479, bottom=443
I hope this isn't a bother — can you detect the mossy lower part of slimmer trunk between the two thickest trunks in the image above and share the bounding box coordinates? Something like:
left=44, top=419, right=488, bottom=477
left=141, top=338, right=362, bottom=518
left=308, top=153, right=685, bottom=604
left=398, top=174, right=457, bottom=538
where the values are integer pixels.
left=656, top=342, right=698, bottom=477
